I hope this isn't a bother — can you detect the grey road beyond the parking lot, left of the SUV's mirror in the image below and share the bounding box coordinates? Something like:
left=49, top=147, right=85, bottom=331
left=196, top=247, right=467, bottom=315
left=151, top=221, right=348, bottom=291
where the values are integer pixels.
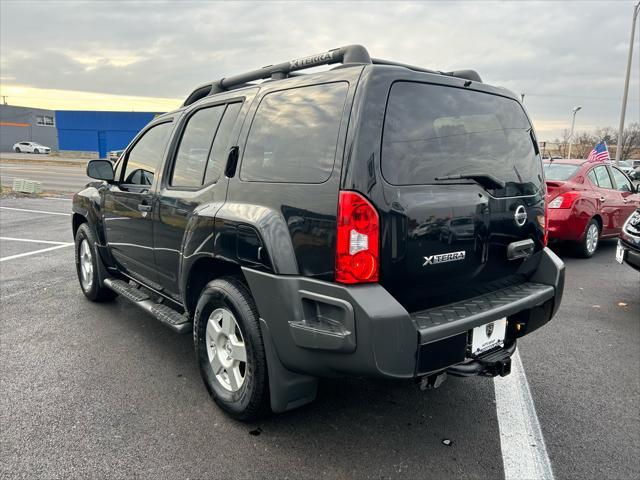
left=0, top=161, right=90, bottom=192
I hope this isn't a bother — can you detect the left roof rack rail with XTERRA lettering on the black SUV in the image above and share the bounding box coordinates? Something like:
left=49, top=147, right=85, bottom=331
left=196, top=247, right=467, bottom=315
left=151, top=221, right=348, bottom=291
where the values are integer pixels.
left=183, top=45, right=371, bottom=106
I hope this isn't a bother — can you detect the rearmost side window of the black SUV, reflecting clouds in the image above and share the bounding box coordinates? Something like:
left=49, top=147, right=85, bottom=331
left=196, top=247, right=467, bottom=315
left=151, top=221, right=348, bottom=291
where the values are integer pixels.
left=240, top=82, right=348, bottom=183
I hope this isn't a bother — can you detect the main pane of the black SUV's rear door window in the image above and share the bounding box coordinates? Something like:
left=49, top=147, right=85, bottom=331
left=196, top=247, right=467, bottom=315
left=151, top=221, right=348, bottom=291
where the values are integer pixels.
left=171, top=105, right=225, bottom=187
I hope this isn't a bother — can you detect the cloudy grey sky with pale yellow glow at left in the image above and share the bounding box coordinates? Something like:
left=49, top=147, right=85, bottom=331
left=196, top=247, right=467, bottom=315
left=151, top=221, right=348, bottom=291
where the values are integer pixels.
left=0, top=0, right=640, bottom=140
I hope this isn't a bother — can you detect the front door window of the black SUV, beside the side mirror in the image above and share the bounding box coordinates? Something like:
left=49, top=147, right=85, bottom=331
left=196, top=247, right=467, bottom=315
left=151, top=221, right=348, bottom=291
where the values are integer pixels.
left=124, top=123, right=171, bottom=185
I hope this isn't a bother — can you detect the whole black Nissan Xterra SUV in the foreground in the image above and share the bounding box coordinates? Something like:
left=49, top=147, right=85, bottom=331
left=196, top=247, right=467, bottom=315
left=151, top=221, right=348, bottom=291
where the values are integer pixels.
left=73, top=45, right=564, bottom=419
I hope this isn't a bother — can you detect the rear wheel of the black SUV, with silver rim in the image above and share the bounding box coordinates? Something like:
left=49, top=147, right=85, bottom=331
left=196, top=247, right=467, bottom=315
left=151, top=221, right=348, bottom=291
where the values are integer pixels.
left=193, top=277, right=270, bottom=421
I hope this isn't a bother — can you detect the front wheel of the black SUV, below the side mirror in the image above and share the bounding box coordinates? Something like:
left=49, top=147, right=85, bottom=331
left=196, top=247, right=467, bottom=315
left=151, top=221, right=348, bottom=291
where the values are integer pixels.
left=75, top=223, right=117, bottom=302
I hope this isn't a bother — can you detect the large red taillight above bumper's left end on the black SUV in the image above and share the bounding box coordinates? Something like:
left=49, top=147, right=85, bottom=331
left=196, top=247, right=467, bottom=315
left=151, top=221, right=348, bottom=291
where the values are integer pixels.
left=336, top=192, right=380, bottom=283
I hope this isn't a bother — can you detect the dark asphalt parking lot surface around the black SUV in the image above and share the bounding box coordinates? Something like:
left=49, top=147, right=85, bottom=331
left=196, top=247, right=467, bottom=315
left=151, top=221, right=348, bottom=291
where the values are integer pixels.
left=0, top=198, right=640, bottom=479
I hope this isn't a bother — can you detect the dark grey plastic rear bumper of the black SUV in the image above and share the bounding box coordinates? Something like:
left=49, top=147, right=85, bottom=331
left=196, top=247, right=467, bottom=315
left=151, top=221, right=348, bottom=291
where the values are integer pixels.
left=243, top=249, right=564, bottom=378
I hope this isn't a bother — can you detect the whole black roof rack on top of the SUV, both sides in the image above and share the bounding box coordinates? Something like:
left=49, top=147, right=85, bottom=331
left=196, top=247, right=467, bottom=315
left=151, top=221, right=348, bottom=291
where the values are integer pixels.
left=182, top=45, right=482, bottom=107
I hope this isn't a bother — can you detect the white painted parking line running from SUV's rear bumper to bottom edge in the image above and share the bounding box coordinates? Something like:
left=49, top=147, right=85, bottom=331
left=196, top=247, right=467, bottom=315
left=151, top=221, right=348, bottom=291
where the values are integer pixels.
left=494, top=350, right=554, bottom=480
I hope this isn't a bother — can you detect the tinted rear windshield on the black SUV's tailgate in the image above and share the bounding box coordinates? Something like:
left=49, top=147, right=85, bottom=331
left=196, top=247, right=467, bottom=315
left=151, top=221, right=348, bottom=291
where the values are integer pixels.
left=382, top=82, right=542, bottom=196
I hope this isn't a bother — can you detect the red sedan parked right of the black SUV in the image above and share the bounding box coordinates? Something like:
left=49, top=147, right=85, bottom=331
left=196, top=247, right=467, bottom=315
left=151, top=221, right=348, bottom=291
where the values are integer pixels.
left=544, top=160, right=640, bottom=258
